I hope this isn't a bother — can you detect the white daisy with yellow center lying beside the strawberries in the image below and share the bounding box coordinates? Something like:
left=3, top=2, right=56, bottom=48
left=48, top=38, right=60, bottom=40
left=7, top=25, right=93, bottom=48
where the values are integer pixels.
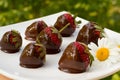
left=88, top=38, right=120, bottom=67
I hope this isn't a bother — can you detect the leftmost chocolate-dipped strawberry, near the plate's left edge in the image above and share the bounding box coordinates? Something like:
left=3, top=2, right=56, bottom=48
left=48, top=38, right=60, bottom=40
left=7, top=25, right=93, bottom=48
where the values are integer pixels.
left=0, top=30, right=22, bottom=53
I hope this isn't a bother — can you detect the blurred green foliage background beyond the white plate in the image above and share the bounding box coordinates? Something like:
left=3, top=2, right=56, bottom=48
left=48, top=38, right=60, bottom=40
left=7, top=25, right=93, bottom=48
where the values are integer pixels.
left=0, top=0, right=120, bottom=80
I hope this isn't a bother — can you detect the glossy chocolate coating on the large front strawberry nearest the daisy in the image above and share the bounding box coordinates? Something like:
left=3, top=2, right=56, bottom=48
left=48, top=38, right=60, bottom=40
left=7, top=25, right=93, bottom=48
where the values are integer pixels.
left=58, top=43, right=90, bottom=73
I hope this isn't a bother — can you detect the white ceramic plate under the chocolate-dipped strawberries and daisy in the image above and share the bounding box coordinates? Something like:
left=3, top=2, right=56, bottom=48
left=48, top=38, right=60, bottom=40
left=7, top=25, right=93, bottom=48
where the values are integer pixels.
left=0, top=11, right=120, bottom=80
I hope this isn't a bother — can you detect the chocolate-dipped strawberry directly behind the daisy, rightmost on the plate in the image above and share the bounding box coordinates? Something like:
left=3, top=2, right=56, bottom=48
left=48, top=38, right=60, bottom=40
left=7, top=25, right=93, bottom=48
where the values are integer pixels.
left=76, top=22, right=103, bottom=44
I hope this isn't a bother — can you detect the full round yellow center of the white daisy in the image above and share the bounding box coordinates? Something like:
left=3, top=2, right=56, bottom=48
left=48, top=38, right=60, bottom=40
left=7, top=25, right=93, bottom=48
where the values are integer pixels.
left=96, top=48, right=109, bottom=61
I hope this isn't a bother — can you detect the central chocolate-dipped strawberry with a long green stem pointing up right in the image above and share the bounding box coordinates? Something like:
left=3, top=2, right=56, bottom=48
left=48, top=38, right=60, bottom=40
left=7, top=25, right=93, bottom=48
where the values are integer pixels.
left=36, top=27, right=62, bottom=54
